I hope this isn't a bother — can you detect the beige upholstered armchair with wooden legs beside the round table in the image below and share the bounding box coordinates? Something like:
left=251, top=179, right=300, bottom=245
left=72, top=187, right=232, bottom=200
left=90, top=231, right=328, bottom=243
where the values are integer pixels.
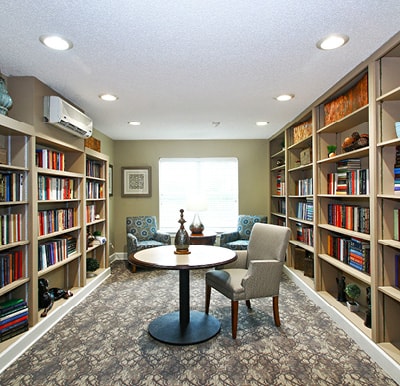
left=205, top=223, right=290, bottom=339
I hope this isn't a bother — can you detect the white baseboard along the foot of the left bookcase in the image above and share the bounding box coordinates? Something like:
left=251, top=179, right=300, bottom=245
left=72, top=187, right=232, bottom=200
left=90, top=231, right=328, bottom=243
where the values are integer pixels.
left=0, top=268, right=111, bottom=373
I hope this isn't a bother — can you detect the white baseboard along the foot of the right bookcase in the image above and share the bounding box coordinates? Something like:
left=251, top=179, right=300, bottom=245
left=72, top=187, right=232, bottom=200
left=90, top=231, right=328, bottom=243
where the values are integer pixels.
left=284, top=266, right=400, bottom=384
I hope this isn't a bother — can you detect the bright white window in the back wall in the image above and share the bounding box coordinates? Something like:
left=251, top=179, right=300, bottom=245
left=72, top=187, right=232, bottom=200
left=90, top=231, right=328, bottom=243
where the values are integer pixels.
left=159, top=158, right=238, bottom=232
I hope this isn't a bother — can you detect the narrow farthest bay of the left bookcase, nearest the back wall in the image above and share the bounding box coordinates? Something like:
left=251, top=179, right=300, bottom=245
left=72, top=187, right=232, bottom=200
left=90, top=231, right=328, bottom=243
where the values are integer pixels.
left=85, top=148, right=109, bottom=278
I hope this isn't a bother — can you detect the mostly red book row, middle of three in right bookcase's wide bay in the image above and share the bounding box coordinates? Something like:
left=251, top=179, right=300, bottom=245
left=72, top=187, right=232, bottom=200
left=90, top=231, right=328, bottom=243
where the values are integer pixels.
left=328, top=203, right=370, bottom=234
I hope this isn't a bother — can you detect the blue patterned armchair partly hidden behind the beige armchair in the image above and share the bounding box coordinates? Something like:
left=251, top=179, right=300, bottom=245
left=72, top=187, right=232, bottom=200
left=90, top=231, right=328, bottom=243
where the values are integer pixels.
left=220, top=214, right=267, bottom=251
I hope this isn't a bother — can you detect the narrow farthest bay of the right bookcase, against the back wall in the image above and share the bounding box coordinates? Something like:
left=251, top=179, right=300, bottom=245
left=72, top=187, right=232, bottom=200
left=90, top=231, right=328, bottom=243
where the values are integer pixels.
left=269, top=131, right=286, bottom=225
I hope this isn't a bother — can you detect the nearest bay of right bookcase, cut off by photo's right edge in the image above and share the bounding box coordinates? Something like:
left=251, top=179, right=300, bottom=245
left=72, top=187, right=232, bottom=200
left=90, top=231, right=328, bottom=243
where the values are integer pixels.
left=373, top=45, right=400, bottom=362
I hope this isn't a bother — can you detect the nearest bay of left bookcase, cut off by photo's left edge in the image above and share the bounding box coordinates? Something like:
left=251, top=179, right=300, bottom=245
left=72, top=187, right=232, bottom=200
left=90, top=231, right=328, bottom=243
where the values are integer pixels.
left=0, top=115, right=34, bottom=351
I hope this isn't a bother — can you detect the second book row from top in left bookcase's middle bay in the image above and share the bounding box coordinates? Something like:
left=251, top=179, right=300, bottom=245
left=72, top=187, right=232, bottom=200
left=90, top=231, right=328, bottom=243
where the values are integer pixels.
left=38, top=175, right=75, bottom=200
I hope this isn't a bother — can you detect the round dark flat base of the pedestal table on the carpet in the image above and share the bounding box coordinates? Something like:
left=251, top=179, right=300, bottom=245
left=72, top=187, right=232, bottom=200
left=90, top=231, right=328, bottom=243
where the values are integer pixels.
left=149, top=311, right=221, bottom=345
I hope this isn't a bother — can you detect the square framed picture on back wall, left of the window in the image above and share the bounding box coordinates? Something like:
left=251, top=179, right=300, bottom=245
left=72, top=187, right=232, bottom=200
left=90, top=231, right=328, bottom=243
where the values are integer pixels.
left=121, top=166, right=151, bottom=197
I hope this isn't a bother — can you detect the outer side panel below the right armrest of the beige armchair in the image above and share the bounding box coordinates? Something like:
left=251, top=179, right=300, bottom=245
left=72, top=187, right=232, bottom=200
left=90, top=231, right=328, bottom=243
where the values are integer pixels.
left=242, top=260, right=283, bottom=299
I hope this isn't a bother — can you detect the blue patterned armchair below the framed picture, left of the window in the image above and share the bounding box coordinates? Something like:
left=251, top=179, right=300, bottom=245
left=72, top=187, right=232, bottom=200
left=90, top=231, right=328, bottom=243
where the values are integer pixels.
left=126, top=216, right=171, bottom=272
